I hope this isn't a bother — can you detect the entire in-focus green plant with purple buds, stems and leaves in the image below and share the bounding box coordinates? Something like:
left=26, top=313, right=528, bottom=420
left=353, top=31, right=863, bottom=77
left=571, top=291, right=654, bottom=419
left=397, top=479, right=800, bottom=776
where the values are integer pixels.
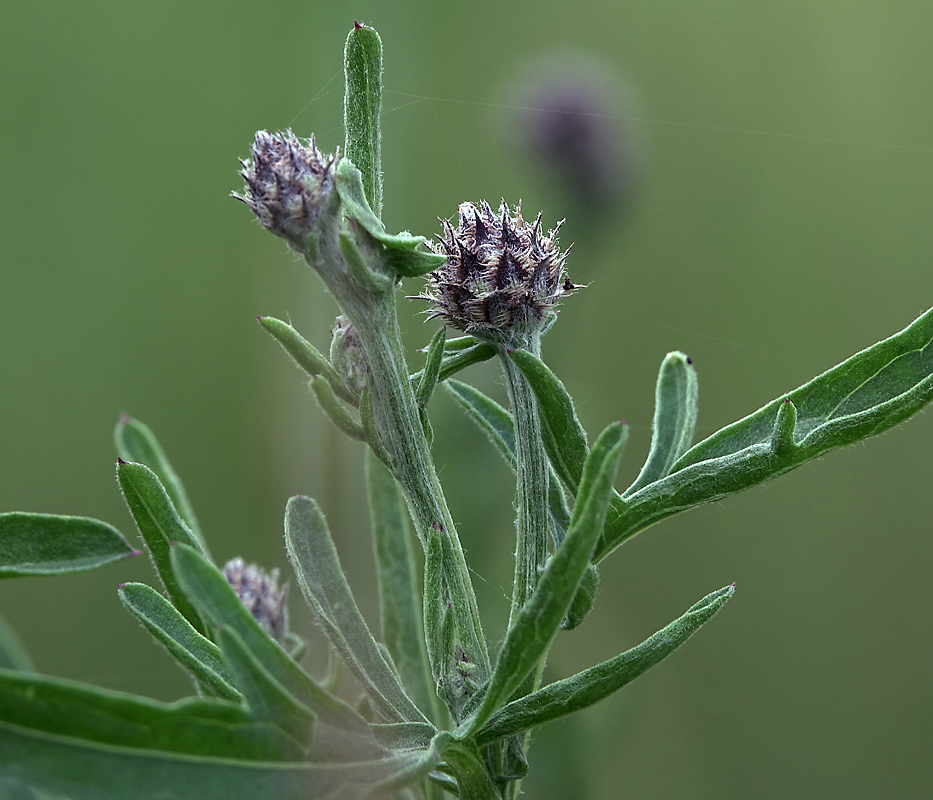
left=0, top=25, right=933, bottom=800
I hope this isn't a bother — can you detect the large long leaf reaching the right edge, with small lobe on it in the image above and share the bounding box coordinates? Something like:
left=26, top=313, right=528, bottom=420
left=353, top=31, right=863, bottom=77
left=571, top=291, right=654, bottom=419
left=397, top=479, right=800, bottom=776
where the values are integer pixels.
left=593, top=310, right=933, bottom=561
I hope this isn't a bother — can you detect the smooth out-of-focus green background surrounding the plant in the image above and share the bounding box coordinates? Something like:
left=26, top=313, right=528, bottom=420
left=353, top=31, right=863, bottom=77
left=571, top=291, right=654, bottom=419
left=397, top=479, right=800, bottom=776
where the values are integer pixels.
left=0, top=0, right=933, bottom=800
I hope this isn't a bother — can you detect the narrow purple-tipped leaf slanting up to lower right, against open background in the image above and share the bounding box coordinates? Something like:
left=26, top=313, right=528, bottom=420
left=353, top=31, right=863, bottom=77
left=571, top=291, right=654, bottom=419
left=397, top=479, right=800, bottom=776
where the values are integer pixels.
left=476, top=586, right=735, bottom=745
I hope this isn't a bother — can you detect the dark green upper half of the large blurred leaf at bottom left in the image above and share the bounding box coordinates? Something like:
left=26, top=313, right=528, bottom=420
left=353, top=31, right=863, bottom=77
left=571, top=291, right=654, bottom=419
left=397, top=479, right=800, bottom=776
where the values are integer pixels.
left=0, top=670, right=299, bottom=770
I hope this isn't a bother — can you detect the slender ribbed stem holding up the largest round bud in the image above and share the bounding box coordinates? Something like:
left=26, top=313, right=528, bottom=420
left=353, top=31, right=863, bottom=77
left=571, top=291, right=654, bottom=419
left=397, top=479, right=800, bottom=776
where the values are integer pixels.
left=500, top=333, right=548, bottom=627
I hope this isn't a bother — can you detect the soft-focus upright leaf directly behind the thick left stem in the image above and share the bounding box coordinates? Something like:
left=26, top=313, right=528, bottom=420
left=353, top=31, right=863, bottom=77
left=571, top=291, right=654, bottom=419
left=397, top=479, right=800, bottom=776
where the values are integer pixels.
left=366, top=453, right=439, bottom=720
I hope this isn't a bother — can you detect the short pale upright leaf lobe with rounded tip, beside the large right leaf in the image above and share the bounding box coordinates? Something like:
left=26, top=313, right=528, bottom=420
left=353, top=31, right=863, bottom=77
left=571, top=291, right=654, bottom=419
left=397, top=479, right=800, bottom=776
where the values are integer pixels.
left=622, top=352, right=697, bottom=497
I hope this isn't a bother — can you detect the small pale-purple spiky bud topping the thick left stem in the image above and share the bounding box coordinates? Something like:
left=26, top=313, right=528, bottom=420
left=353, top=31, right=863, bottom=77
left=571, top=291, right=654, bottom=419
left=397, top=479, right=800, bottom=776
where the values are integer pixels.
left=234, top=131, right=336, bottom=253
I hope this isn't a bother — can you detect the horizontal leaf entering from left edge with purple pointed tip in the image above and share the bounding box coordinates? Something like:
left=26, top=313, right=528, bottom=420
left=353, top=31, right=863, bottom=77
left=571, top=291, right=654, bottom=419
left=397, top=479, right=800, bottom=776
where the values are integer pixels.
left=0, top=511, right=138, bottom=578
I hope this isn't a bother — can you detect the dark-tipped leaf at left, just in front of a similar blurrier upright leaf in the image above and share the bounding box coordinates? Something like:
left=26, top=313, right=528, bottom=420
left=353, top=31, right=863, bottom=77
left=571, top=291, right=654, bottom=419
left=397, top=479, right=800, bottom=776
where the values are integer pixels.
left=117, top=460, right=205, bottom=633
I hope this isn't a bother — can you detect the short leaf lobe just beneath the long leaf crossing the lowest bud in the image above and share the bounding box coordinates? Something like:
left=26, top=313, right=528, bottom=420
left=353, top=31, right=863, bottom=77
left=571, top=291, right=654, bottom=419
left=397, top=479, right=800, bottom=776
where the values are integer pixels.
left=217, top=626, right=315, bottom=750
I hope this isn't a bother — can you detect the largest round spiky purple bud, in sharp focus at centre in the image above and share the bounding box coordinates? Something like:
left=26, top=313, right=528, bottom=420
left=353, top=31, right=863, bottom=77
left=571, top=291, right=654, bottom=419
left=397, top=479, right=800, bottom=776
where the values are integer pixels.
left=421, top=201, right=579, bottom=343
